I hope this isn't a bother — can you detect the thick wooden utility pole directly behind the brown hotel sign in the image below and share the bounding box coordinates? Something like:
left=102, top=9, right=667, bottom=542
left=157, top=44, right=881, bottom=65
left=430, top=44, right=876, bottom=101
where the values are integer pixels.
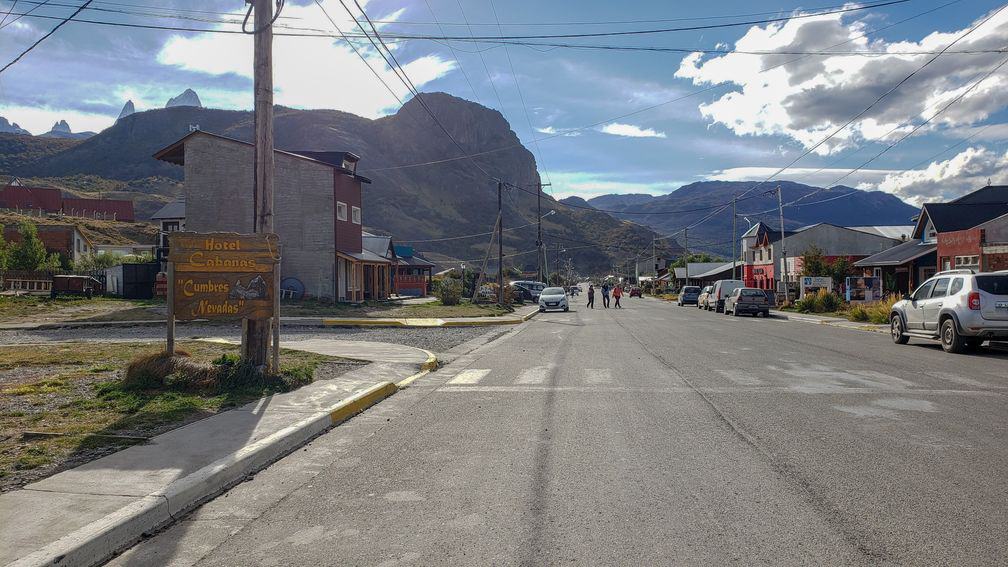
left=242, top=0, right=280, bottom=370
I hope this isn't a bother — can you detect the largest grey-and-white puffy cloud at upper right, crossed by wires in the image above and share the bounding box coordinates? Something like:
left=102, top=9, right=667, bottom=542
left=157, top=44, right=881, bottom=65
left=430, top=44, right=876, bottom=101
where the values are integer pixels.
left=675, top=5, right=1008, bottom=154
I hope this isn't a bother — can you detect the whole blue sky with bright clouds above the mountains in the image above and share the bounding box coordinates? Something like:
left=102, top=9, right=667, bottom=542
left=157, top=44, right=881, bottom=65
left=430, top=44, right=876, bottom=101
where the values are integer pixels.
left=0, top=0, right=1008, bottom=204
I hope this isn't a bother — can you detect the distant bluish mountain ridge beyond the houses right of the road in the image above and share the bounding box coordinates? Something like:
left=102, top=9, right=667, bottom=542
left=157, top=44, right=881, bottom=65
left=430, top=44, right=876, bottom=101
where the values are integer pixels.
left=588, top=181, right=918, bottom=254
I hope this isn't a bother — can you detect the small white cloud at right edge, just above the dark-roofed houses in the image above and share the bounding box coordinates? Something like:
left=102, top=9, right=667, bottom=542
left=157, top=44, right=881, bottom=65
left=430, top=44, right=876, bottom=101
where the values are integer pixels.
left=878, top=147, right=1008, bottom=205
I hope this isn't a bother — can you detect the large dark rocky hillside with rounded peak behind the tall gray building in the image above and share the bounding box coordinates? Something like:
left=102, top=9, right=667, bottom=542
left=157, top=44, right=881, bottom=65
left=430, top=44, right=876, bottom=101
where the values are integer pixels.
left=0, top=93, right=677, bottom=271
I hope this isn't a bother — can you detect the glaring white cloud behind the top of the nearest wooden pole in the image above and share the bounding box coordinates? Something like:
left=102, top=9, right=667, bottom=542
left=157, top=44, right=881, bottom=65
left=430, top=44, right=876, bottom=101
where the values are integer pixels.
left=157, top=0, right=455, bottom=118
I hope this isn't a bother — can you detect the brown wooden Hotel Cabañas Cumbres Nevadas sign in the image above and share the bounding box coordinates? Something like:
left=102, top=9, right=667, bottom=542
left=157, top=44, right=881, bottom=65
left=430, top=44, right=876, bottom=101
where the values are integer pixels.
left=168, top=232, right=279, bottom=320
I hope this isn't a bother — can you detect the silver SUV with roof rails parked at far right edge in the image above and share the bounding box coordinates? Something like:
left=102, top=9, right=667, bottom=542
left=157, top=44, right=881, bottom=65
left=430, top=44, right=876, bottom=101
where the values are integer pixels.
left=889, top=269, right=1008, bottom=353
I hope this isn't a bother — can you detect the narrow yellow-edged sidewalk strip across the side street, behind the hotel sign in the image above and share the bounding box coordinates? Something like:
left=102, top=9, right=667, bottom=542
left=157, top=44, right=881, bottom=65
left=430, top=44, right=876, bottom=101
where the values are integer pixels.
left=0, top=306, right=539, bottom=331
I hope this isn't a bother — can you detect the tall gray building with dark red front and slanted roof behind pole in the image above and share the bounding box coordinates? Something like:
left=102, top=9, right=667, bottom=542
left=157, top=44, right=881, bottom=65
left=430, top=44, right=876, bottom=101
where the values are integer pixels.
left=154, top=130, right=379, bottom=302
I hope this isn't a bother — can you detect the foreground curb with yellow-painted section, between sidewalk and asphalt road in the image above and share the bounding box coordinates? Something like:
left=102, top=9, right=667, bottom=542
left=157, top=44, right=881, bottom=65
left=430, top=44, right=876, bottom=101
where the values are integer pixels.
left=7, top=379, right=401, bottom=567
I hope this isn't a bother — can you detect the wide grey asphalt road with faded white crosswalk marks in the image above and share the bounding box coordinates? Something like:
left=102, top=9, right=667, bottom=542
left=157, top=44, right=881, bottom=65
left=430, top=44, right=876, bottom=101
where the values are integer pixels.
left=110, top=296, right=1008, bottom=565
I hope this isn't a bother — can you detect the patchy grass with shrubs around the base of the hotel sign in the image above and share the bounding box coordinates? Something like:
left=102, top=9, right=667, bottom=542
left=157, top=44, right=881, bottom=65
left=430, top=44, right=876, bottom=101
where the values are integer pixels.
left=0, top=341, right=339, bottom=490
